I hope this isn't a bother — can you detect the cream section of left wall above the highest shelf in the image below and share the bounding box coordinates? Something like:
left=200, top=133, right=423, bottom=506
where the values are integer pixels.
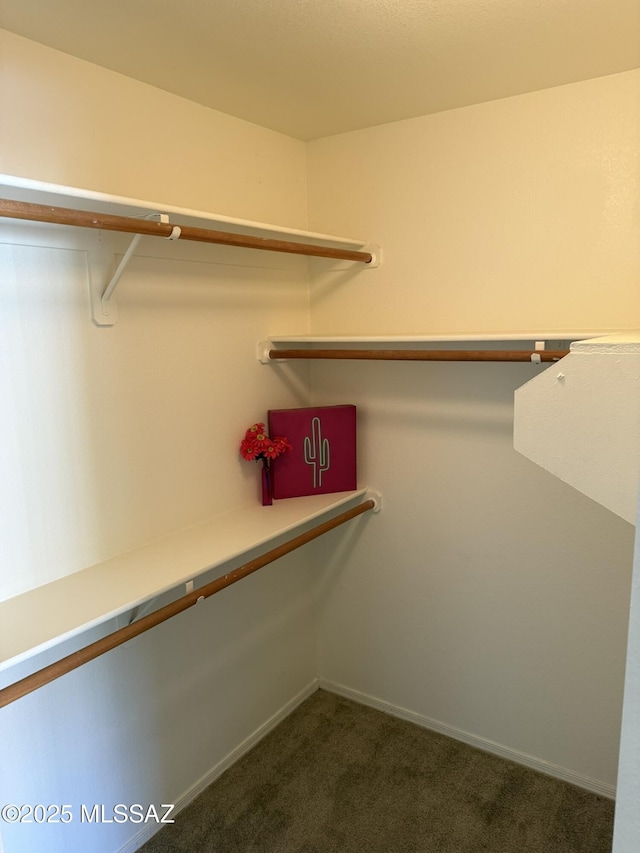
left=0, top=30, right=307, bottom=228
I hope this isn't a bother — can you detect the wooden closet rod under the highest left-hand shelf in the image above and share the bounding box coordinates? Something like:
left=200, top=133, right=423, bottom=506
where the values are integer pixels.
left=0, top=199, right=373, bottom=264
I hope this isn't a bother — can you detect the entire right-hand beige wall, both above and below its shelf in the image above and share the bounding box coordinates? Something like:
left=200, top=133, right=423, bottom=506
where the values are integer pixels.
left=309, top=72, right=640, bottom=790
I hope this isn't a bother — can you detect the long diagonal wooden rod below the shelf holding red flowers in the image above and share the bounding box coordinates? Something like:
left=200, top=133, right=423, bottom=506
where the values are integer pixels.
left=0, top=500, right=376, bottom=708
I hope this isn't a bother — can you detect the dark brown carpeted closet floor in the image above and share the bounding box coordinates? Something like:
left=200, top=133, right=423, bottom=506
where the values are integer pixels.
left=140, top=690, right=614, bottom=853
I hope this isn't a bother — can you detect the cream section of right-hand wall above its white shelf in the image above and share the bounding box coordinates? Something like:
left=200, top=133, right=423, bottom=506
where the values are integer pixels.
left=309, top=71, right=640, bottom=334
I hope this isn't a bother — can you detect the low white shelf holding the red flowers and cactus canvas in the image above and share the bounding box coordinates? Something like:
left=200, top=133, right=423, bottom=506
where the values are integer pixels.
left=0, top=488, right=372, bottom=670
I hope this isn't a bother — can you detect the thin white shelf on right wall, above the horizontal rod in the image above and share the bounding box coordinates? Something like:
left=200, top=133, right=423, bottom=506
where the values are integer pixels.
left=269, top=329, right=626, bottom=344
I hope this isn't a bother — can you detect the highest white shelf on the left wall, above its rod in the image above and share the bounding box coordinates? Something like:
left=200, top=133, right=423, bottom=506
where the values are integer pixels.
left=0, top=174, right=369, bottom=248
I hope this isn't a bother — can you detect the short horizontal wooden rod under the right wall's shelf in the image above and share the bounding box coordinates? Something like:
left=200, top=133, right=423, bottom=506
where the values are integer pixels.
left=269, top=349, right=569, bottom=363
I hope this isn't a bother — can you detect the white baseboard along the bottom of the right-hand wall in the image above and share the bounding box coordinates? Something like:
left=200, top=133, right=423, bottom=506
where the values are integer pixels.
left=318, top=678, right=616, bottom=800
